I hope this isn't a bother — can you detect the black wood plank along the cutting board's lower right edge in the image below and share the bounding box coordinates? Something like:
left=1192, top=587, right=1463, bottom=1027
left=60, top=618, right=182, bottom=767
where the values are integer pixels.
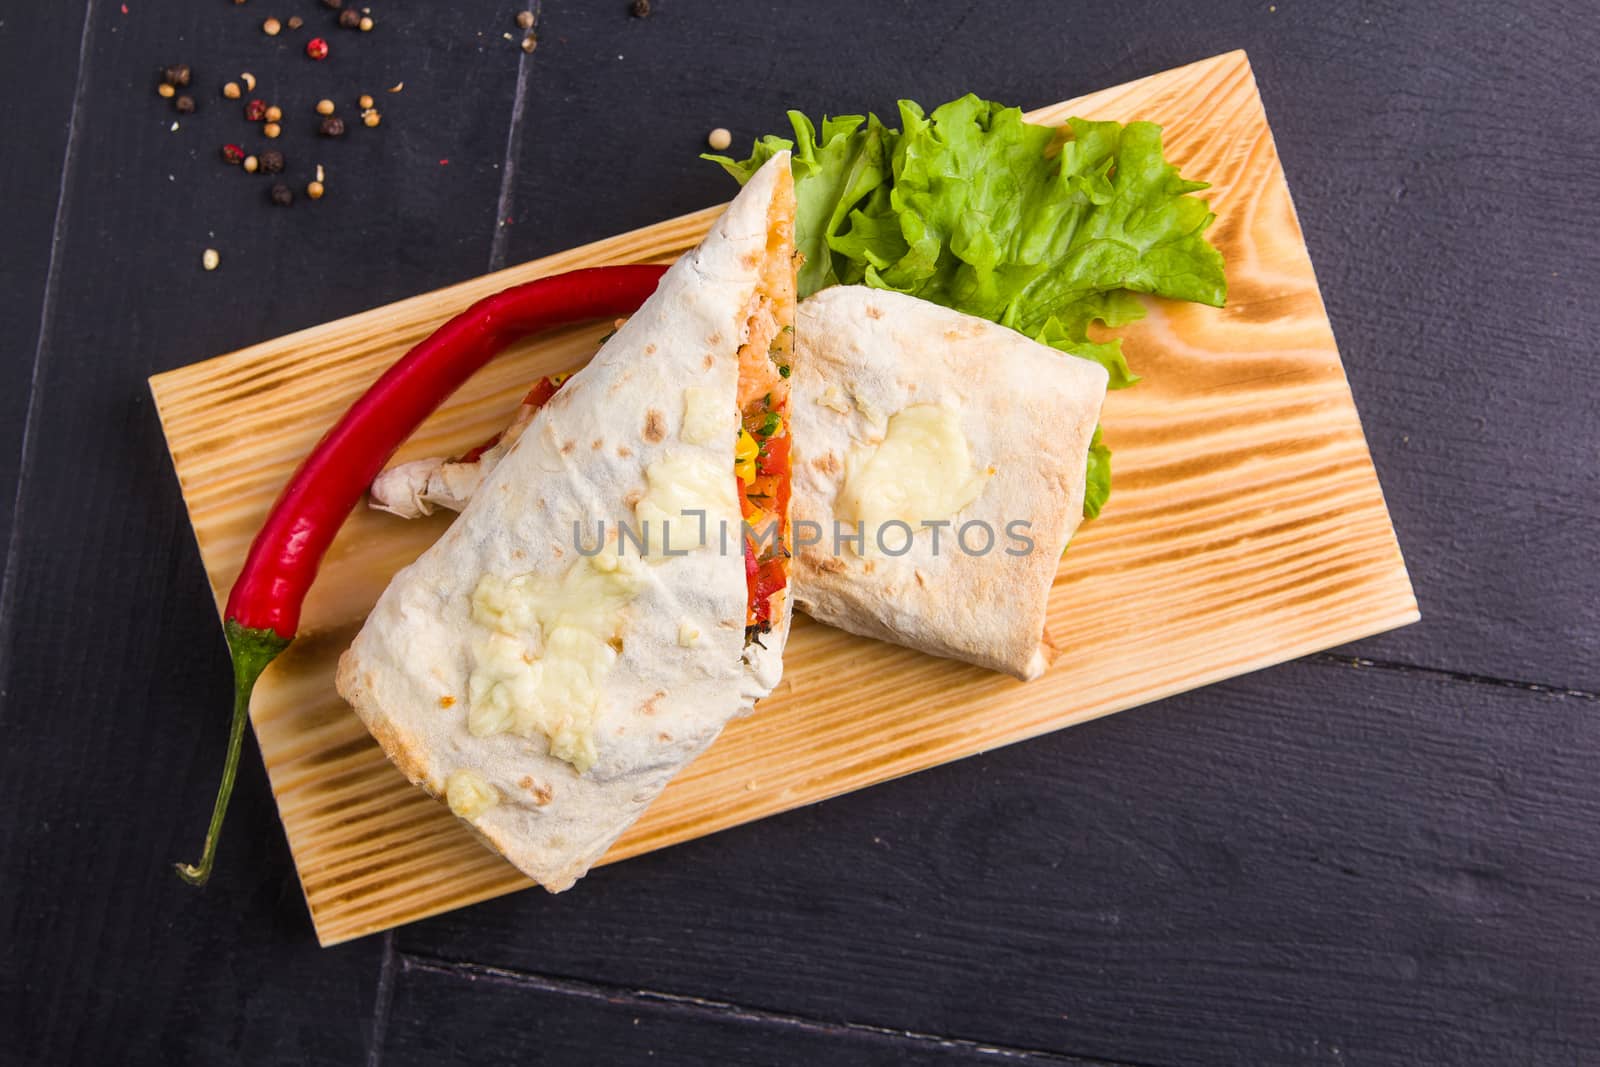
left=400, top=662, right=1600, bottom=1064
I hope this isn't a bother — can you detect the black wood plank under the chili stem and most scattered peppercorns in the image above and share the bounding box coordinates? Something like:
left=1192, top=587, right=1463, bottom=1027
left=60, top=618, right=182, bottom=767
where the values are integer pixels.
left=0, top=0, right=522, bottom=1064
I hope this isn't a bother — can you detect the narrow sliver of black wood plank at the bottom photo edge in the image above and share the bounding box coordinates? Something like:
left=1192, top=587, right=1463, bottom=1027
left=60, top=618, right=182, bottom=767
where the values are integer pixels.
left=379, top=958, right=1115, bottom=1067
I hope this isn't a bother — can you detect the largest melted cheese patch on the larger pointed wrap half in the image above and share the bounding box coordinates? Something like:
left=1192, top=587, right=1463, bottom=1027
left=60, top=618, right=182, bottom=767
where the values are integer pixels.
left=467, top=549, right=648, bottom=774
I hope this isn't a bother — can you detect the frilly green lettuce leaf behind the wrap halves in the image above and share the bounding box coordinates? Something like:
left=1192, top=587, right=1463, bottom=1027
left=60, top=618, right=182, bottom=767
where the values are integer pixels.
left=707, top=94, right=1227, bottom=518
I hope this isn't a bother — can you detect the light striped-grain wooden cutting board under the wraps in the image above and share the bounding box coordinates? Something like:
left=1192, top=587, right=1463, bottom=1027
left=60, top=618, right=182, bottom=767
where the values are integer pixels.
left=150, top=51, right=1418, bottom=944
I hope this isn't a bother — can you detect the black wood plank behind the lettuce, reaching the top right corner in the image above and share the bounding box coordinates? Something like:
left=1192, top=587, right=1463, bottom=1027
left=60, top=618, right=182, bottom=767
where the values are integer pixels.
left=509, top=0, right=1600, bottom=691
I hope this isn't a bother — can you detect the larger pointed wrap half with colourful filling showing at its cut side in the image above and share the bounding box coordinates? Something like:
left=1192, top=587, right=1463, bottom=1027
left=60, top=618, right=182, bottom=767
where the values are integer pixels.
left=338, top=155, right=794, bottom=891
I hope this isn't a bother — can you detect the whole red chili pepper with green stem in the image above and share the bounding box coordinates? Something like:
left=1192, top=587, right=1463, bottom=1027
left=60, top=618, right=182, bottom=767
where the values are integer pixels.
left=178, top=266, right=666, bottom=885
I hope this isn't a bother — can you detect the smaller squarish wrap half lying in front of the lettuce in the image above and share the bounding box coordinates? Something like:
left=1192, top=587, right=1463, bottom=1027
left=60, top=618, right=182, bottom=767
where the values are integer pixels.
left=792, top=286, right=1107, bottom=680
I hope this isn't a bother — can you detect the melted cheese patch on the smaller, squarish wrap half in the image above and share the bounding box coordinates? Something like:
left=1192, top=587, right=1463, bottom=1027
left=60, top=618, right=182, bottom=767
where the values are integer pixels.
left=834, top=403, right=994, bottom=549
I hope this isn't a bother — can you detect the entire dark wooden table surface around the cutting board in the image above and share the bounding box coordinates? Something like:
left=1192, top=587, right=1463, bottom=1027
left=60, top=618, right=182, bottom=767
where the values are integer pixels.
left=0, top=0, right=1600, bottom=1067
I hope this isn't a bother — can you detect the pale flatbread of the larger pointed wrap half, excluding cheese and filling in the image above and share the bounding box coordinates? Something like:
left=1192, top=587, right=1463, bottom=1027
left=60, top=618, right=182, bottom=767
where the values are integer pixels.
left=338, top=154, right=794, bottom=891
